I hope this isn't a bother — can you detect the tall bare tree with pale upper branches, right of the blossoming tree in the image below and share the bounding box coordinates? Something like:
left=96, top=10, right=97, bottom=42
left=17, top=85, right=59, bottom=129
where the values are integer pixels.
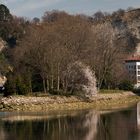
left=87, top=22, right=124, bottom=88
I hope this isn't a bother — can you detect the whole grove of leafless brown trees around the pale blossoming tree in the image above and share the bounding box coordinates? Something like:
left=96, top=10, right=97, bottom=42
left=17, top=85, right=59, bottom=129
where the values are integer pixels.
left=6, top=7, right=136, bottom=93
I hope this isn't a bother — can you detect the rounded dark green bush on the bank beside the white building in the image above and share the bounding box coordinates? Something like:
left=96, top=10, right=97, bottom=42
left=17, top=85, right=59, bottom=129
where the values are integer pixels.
left=119, top=80, right=134, bottom=91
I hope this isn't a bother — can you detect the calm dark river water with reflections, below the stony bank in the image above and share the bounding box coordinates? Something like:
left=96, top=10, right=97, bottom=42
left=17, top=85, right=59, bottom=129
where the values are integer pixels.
left=0, top=103, right=140, bottom=140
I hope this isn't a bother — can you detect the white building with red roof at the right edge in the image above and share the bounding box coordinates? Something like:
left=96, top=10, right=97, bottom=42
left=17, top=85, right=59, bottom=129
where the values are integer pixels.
left=125, top=56, right=140, bottom=88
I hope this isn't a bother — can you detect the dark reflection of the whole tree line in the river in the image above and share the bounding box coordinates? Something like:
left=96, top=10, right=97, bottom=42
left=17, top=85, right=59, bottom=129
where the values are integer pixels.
left=0, top=110, right=137, bottom=140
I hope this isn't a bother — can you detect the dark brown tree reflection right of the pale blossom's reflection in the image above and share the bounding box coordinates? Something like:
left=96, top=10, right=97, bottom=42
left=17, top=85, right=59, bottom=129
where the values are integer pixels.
left=96, top=110, right=137, bottom=140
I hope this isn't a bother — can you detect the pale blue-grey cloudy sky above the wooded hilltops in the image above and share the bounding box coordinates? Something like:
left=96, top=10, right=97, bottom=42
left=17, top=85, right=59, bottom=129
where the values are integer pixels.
left=0, top=0, right=140, bottom=18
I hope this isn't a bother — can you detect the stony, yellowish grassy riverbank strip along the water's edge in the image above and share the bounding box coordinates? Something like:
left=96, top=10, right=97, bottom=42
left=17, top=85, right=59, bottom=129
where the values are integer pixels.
left=0, top=92, right=140, bottom=111
